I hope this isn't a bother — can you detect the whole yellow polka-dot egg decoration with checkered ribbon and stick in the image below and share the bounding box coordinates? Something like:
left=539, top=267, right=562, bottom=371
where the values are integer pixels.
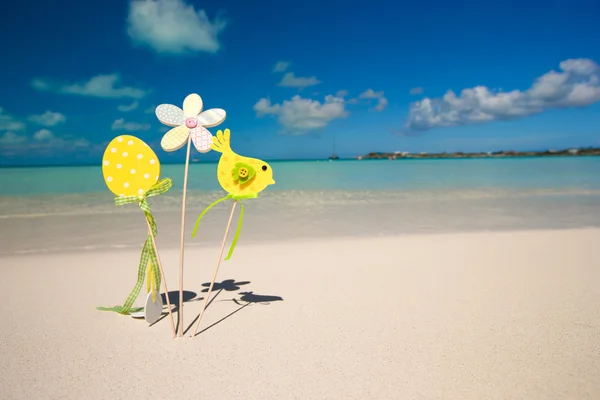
left=97, top=135, right=175, bottom=337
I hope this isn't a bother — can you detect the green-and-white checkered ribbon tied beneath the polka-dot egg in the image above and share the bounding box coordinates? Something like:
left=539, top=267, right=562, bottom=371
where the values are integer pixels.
left=97, top=178, right=173, bottom=315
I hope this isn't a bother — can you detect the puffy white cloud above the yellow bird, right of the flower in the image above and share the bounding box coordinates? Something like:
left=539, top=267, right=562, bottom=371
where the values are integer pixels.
left=254, top=95, right=348, bottom=134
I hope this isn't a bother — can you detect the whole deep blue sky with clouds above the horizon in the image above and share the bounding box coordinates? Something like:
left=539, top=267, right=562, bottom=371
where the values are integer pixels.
left=0, top=0, right=600, bottom=165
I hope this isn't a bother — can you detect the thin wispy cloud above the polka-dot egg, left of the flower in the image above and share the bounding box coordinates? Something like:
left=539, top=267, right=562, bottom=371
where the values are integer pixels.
left=31, top=74, right=148, bottom=99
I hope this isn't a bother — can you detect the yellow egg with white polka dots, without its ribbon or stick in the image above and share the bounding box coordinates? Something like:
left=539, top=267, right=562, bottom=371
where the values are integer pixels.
left=102, top=135, right=160, bottom=197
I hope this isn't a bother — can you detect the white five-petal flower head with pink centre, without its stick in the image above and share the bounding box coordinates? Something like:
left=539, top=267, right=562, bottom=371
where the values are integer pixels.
left=155, top=93, right=227, bottom=153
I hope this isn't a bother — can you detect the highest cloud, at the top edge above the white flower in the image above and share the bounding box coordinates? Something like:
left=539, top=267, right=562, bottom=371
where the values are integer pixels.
left=127, top=0, right=227, bottom=54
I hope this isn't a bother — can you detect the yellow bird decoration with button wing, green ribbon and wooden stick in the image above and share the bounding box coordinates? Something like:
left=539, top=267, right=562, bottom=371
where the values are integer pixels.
left=191, top=129, right=275, bottom=337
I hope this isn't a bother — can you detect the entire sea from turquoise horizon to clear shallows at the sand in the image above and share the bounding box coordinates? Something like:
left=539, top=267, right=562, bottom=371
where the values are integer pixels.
left=0, top=157, right=600, bottom=253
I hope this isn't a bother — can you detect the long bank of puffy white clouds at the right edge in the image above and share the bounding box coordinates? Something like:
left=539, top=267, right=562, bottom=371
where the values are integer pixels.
left=405, top=59, right=600, bottom=131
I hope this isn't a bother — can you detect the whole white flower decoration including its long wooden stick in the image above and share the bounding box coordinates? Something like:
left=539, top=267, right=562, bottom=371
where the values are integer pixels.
left=155, top=93, right=227, bottom=336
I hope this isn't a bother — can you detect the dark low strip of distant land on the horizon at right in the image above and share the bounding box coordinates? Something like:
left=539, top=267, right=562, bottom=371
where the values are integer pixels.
left=357, top=147, right=600, bottom=160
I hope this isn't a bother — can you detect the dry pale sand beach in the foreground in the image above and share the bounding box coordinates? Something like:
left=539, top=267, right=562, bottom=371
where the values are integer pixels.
left=0, top=229, right=600, bottom=400
